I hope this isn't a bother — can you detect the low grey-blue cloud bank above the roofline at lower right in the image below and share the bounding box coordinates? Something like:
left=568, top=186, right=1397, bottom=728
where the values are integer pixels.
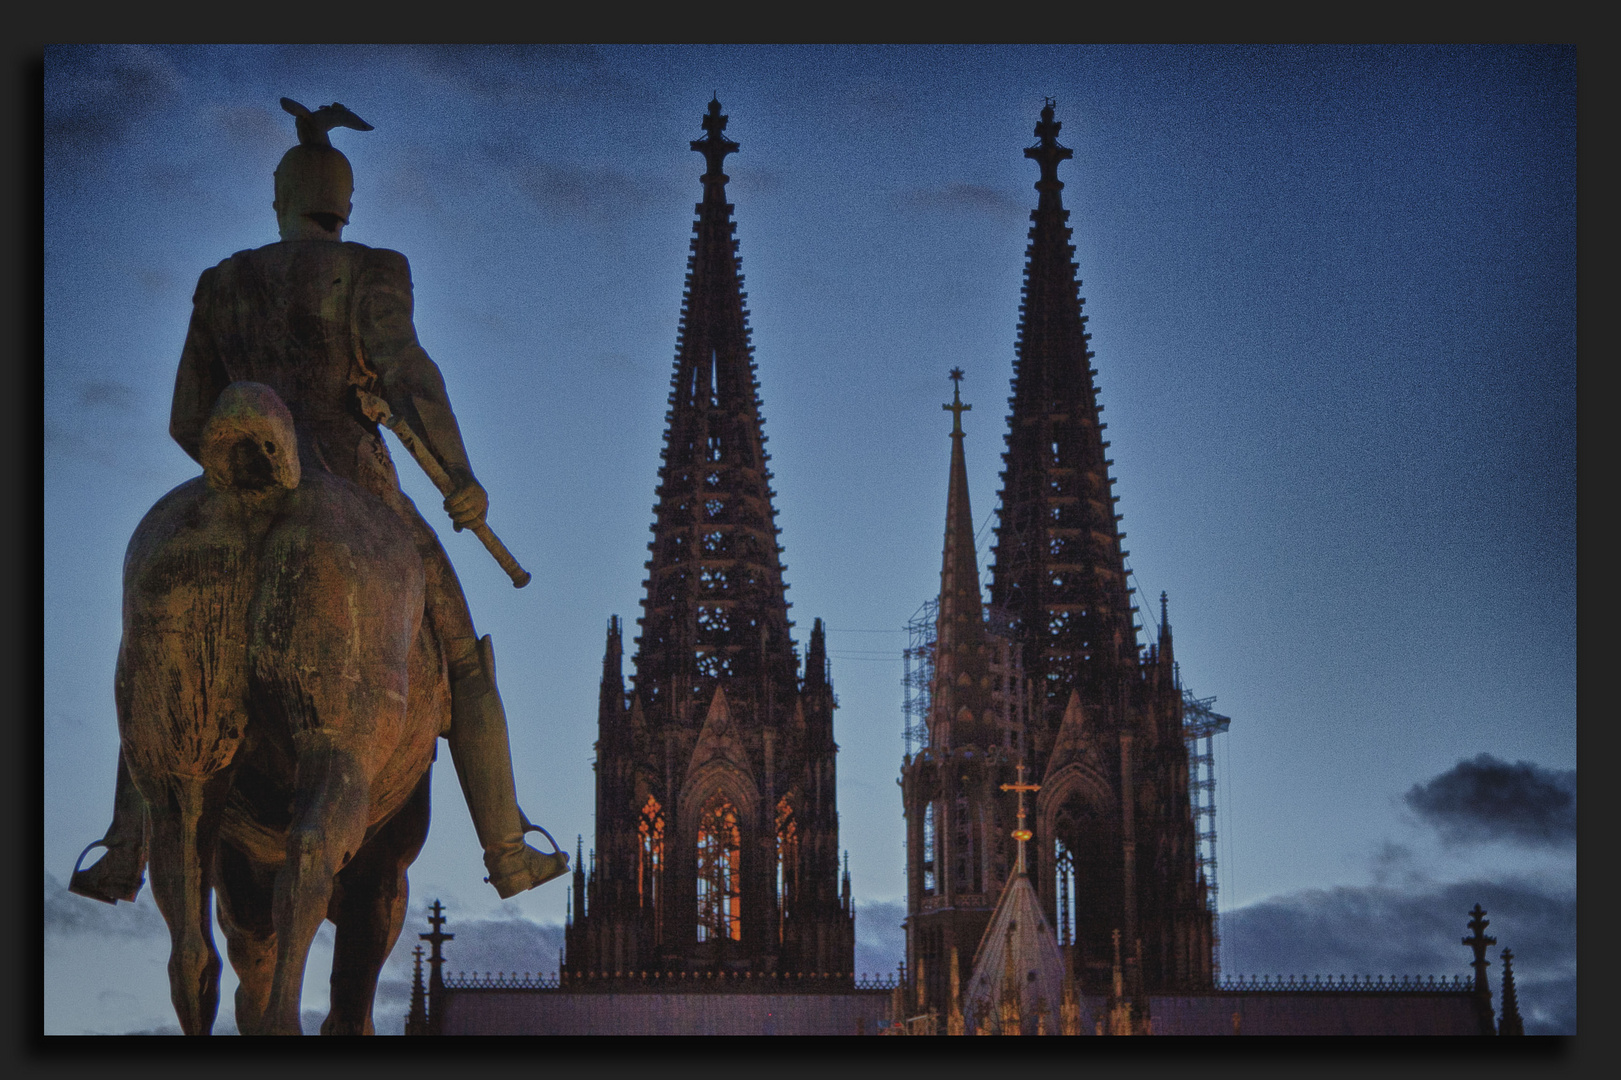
left=1221, top=881, right=1576, bottom=1035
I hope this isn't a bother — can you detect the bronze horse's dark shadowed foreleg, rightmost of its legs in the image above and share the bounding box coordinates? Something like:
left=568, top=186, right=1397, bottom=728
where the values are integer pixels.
left=321, top=772, right=431, bottom=1035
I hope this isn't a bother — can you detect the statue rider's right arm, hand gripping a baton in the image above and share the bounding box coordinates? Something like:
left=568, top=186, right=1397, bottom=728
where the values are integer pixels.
left=355, top=248, right=490, bottom=529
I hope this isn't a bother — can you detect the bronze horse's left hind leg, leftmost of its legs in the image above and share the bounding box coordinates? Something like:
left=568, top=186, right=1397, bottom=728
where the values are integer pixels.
left=143, top=772, right=230, bottom=1035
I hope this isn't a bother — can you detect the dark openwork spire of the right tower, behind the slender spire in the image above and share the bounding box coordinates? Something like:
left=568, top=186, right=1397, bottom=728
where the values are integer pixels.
left=990, top=101, right=1138, bottom=713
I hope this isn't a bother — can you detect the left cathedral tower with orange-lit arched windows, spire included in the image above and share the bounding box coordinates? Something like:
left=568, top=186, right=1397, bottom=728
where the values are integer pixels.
left=564, top=101, right=854, bottom=979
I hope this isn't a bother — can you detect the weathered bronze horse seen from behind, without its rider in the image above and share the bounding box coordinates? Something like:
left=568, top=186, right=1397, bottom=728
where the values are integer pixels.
left=101, top=383, right=450, bottom=1035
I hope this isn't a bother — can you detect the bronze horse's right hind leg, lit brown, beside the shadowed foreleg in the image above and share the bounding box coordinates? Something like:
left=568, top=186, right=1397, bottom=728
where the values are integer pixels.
left=264, top=728, right=371, bottom=1035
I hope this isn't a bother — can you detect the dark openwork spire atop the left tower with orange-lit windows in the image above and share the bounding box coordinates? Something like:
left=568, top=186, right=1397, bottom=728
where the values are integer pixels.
left=635, top=101, right=796, bottom=718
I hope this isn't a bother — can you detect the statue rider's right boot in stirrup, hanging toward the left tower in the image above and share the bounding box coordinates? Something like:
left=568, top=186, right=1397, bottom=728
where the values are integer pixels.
left=449, top=636, right=569, bottom=900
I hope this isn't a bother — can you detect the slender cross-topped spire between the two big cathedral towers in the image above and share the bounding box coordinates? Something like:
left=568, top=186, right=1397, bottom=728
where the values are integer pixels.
left=930, top=368, right=990, bottom=746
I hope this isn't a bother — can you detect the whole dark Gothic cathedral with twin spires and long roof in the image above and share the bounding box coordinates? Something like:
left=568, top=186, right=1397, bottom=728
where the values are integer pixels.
left=407, top=101, right=1520, bottom=1035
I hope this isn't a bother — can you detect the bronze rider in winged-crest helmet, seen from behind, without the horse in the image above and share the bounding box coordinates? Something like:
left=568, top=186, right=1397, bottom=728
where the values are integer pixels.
left=70, top=99, right=567, bottom=903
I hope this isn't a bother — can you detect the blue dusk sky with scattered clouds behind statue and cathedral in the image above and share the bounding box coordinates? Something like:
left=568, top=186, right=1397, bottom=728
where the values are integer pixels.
left=42, top=45, right=1577, bottom=1033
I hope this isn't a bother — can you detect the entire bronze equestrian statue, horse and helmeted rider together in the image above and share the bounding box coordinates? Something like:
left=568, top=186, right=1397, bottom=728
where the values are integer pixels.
left=70, top=99, right=567, bottom=1033
